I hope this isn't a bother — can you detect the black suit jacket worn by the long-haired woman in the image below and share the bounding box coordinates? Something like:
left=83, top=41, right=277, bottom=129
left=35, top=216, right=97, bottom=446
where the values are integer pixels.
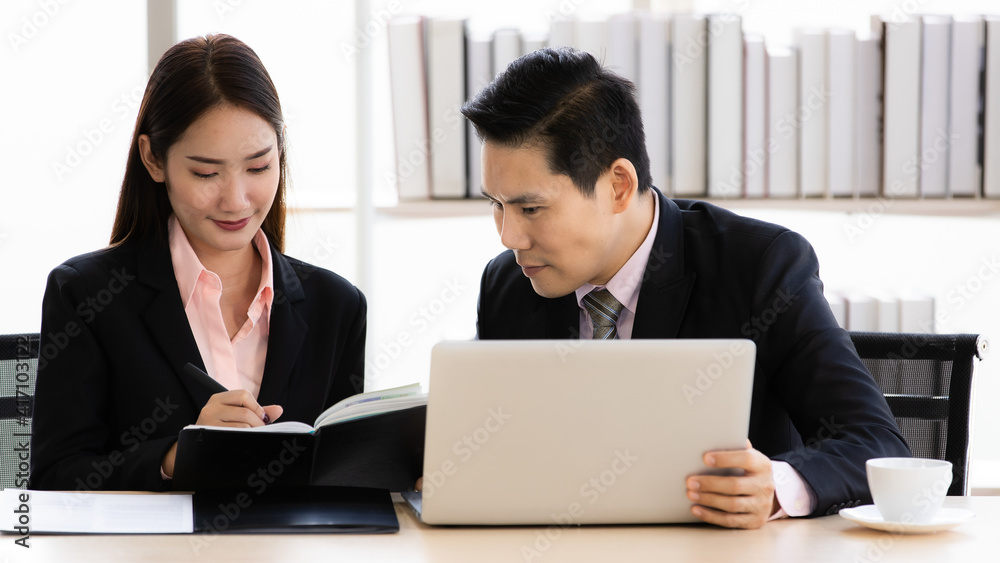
left=30, top=242, right=367, bottom=491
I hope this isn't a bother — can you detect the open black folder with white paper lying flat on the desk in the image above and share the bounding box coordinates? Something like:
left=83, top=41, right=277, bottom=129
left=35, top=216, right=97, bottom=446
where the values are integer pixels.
left=0, top=486, right=399, bottom=545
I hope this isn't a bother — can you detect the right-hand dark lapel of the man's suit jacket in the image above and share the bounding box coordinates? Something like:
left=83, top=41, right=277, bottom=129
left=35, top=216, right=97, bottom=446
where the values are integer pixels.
left=632, top=188, right=696, bottom=339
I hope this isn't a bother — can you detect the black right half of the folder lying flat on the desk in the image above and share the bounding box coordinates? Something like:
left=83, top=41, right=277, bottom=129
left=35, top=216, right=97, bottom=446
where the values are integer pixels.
left=193, top=486, right=399, bottom=534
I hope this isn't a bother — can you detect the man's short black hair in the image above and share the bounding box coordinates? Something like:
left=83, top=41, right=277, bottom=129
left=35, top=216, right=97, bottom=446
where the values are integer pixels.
left=462, top=47, right=653, bottom=196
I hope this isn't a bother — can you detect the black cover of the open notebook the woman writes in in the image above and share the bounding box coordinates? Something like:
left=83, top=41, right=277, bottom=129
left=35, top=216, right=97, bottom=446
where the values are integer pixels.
left=173, top=405, right=427, bottom=491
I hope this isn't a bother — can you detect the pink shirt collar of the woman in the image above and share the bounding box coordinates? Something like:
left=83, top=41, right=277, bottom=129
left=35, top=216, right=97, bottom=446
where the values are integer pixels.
left=167, top=215, right=274, bottom=317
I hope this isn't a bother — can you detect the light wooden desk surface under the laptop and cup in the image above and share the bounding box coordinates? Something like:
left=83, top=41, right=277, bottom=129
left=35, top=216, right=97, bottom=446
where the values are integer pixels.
left=9, top=497, right=1000, bottom=563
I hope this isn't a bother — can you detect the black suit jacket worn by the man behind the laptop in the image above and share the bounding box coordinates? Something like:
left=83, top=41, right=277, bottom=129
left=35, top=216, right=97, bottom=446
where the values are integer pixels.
left=477, top=189, right=910, bottom=516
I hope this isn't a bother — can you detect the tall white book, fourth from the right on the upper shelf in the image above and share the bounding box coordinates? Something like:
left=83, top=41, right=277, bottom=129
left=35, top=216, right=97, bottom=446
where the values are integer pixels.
left=882, top=16, right=922, bottom=197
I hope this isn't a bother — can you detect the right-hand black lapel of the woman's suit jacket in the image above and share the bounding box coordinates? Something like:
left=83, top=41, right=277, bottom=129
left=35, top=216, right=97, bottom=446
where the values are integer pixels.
left=257, top=245, right=309, bottom=405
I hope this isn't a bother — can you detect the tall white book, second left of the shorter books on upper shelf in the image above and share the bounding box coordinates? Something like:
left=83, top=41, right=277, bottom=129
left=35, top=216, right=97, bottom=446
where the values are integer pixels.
left=670, top=14, right=708, bottom=197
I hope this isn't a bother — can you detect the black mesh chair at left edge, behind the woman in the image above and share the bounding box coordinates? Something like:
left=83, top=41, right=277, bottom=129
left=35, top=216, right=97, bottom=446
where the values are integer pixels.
left=0, top=334, right=39, bottom=489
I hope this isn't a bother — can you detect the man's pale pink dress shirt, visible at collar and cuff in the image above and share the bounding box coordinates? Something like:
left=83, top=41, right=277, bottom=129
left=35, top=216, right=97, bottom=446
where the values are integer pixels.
left=576, top=196, right=816, bottom=520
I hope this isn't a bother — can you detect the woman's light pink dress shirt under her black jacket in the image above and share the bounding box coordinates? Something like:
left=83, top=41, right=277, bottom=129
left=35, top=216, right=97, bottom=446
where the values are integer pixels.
left=167, top=216, right=274, bottom=398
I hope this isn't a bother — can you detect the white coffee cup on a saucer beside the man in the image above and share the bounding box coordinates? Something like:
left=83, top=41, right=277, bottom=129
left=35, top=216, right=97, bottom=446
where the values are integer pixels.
left=865, top=457, right=952, bottom=524
